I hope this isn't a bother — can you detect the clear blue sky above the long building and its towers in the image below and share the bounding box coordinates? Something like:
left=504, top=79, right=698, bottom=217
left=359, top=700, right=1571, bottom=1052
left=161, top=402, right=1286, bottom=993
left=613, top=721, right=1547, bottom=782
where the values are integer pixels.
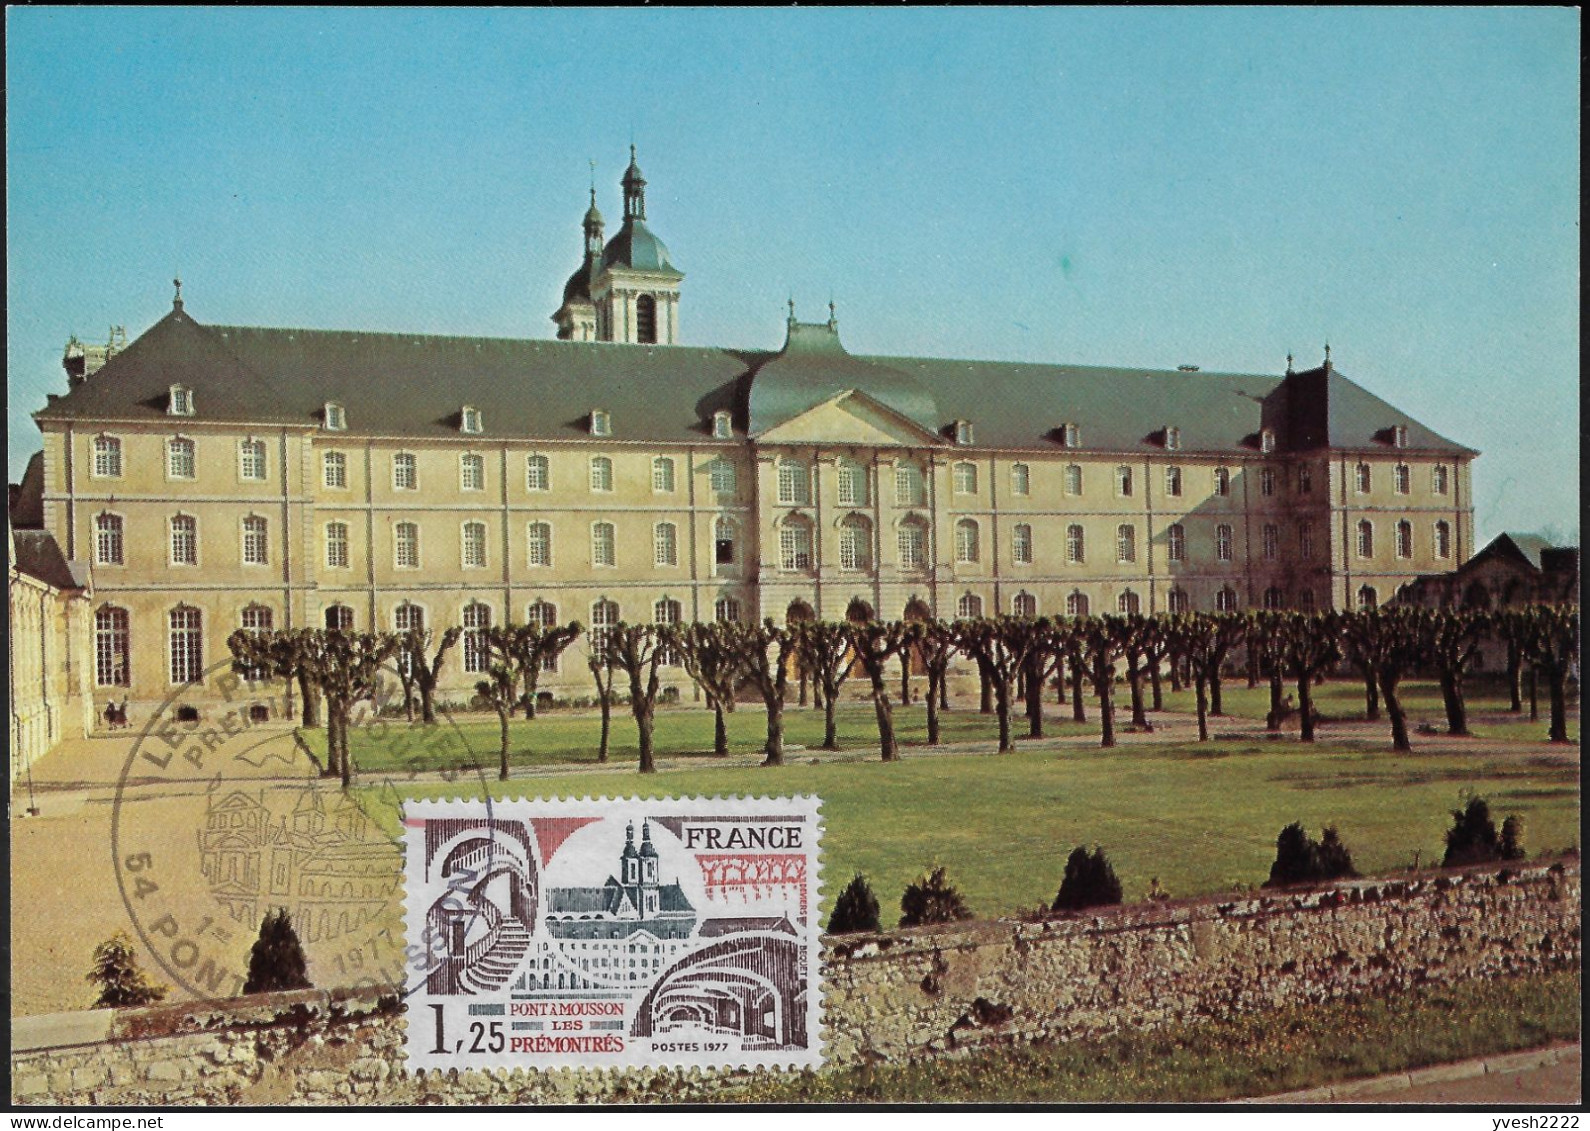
left=6, top=8, right=1579, bottom=538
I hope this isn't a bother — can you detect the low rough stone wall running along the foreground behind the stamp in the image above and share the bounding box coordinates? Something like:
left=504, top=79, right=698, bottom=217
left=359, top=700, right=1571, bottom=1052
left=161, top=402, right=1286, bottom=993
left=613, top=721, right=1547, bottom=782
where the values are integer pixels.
left=11, top=859, right=1580, bottom=1104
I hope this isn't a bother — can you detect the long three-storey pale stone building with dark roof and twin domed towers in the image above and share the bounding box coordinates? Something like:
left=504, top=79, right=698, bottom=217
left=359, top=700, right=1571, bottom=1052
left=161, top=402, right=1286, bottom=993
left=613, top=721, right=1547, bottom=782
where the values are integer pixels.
left=15, top=153, right=1476, bottom=703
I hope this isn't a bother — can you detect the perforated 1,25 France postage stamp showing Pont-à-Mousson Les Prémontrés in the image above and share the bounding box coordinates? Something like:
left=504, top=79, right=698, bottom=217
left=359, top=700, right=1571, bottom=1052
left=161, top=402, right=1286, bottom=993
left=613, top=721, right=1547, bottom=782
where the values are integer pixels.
left=404, top=797, right=822, bottom=1069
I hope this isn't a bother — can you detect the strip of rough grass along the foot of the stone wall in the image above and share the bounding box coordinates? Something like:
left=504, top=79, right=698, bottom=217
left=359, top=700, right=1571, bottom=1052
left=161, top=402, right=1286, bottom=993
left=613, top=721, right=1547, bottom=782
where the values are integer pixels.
left=683, top=972, right=1580, bottom=1104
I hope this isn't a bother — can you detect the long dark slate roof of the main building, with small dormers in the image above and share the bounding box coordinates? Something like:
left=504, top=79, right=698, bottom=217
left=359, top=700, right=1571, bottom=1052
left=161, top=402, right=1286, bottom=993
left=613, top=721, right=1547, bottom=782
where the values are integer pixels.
left=35, top=309, right=1474, bottom=455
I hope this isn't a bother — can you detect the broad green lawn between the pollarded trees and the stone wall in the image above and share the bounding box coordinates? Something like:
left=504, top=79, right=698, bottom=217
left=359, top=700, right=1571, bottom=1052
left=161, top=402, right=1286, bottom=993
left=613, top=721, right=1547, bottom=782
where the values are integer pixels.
left=355, top=706, right=1579, bottom=921
